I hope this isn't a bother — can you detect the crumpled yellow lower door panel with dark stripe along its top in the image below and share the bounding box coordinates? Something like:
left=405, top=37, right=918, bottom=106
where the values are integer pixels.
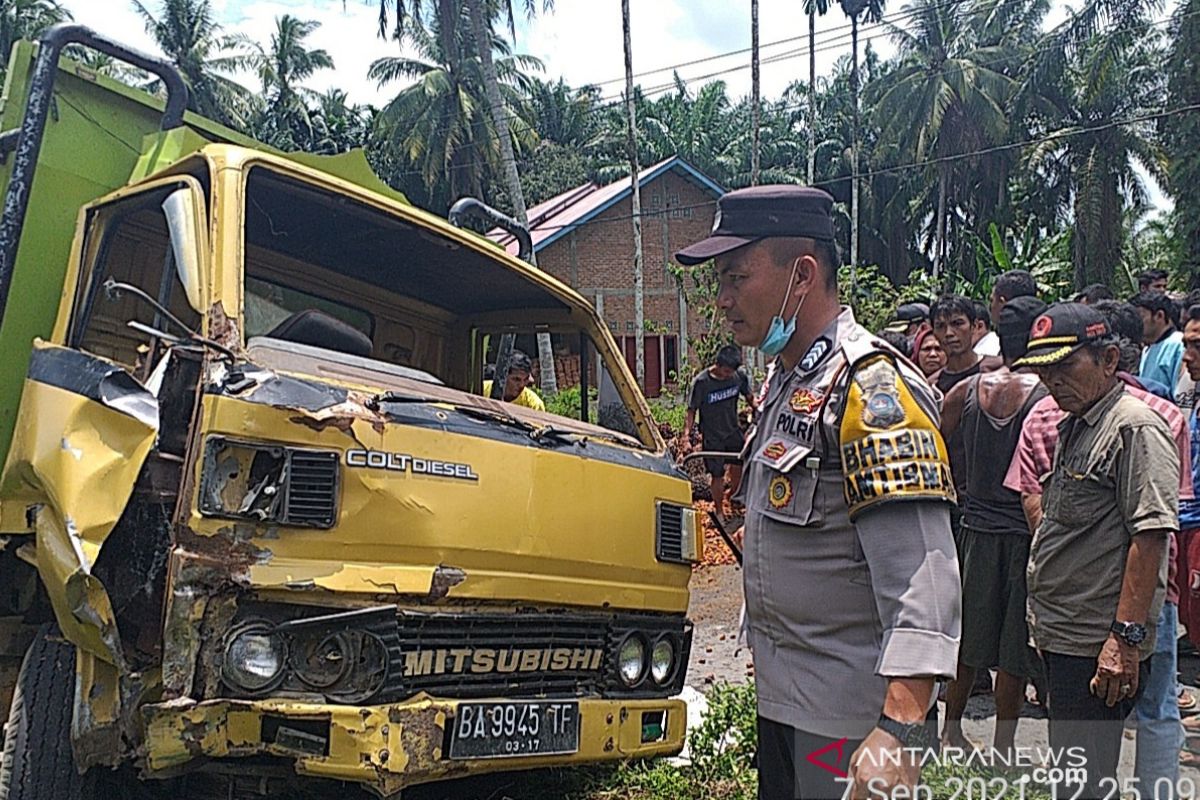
left=0, top=341, right=158, bottom=667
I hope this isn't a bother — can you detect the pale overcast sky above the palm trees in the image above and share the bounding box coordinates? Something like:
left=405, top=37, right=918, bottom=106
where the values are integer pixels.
left=60, top=0, right=1176, bottom=206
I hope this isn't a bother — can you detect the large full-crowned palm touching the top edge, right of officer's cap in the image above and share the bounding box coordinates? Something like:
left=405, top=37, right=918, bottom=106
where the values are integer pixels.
left=868, top=0, right=1021, bottom=277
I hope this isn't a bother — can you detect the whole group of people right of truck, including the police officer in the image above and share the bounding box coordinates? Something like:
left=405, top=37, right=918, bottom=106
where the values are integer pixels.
left=676, top=186, right=1200, bottom=799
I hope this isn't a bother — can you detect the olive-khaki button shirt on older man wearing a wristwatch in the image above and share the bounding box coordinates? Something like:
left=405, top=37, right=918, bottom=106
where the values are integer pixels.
left=1027, top=384, right=1180, bottom=658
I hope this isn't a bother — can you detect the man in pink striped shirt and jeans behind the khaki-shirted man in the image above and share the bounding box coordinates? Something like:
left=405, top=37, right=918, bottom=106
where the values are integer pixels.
left=1004, top=300, right=1195, bottom=787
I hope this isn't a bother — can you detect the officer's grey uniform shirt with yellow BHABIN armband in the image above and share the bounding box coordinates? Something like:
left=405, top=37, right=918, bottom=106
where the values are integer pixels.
left=742, top=309, right=961, bottom=738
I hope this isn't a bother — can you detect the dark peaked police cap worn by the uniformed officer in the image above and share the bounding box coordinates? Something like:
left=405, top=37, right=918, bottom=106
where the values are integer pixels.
left=676, top=185, right=834, bottom=266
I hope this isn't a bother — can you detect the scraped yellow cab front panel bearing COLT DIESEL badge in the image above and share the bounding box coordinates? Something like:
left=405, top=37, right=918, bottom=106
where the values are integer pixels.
left=186, top=396, right=691, bottom=614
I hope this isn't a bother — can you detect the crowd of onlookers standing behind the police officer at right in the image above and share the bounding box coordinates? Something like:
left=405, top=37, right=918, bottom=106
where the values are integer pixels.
left=864, top=270, right=1200, bottom=787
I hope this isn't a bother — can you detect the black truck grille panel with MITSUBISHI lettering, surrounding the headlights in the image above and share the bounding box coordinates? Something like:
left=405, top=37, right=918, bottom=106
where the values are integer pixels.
left=214, top=603, right=691, bottom=705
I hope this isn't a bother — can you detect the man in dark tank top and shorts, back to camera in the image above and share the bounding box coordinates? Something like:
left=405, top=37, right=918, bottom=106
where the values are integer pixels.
left=942, top=296, right=1045, bottom=752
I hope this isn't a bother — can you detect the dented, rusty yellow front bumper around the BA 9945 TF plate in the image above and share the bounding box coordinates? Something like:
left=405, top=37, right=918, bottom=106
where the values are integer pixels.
left=144, top=696, right=686, bottom=795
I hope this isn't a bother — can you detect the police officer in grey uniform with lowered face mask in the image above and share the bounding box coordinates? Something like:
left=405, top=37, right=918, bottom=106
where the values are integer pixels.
left=676, top=186, right=961, bottom=800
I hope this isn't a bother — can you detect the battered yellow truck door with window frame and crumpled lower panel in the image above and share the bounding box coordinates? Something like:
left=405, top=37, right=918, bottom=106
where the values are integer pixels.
left=0, top=176, right=208, bottom=667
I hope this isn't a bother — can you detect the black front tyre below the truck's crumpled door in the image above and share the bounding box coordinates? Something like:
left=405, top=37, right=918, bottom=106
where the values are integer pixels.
left=0, top=625, right=91, bottom=800
